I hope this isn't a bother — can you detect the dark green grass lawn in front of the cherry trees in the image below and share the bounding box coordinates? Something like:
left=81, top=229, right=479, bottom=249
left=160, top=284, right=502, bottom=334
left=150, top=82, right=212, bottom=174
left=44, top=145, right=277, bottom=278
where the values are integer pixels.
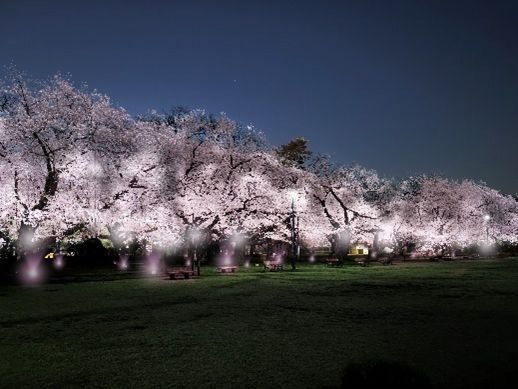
left=0, top=258, right=518, bottom=388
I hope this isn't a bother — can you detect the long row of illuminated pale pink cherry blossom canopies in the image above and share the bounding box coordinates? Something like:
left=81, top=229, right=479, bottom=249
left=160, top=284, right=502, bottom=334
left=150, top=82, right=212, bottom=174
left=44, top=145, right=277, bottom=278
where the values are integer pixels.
left=0, top=75, right=518, bottom=270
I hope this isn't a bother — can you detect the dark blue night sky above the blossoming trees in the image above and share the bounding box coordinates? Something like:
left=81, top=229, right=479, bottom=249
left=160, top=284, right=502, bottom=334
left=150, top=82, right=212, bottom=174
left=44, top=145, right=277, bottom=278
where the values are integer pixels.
left=0, top=0, right=518, bottom=193
